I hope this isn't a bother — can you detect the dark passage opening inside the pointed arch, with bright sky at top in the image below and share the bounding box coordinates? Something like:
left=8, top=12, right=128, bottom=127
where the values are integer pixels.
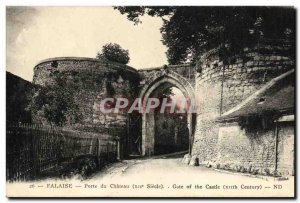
left=151, top=85, right=189, bottom=155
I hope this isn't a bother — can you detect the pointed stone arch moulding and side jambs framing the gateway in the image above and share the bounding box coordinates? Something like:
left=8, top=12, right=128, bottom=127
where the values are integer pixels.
left=140, top=71, right=196, bottom=156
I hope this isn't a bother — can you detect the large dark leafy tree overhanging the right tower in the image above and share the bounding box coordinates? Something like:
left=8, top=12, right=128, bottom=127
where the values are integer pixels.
left=115, top=6, right=295, bottom=64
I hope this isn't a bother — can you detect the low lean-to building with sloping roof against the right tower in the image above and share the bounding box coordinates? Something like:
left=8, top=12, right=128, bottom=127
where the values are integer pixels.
left=217, top=69, right=295, bottom=176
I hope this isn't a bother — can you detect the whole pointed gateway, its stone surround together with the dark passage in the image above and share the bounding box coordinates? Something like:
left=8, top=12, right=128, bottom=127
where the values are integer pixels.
left=141, top=77, right=195, bottom=156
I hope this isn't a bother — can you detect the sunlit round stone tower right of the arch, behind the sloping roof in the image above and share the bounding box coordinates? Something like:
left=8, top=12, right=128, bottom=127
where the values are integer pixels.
left=192, top=41, right=295, bottom=167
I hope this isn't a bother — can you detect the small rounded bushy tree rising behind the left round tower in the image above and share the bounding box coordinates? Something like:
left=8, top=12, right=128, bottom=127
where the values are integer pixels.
left=97, top=43, right=130, bottom=64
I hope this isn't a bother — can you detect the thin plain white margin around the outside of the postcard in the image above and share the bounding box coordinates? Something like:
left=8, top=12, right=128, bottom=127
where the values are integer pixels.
left=0, top=0, right=300, bottom=202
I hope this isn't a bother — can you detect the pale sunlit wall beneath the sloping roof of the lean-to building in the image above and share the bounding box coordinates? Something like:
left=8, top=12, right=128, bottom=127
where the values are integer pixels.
left=215, top=119, right=294, bottom=176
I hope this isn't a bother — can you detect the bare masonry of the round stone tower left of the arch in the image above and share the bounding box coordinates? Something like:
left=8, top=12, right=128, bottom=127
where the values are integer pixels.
left=33, top=58, right=139, bottom=143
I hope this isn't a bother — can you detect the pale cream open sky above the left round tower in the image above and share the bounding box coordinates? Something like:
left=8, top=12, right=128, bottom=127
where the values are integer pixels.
left=6, top=7, right=167, bottom=81
